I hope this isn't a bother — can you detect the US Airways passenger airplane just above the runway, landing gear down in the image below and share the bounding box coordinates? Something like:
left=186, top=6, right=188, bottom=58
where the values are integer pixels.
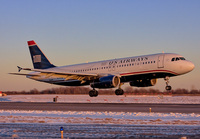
left=10, top=40, right=195, bottom=97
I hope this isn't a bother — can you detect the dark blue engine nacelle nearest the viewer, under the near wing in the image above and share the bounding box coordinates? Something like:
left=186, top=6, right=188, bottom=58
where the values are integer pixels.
left=91, top=75, right=120, bottom=88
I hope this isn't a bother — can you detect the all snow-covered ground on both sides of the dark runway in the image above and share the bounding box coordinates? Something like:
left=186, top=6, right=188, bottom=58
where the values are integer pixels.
left=0, top=95, right=200, bottom=139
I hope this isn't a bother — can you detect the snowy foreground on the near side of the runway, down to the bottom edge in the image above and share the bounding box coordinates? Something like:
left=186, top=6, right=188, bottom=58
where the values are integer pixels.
left=0, top=110, right=200, bottom=139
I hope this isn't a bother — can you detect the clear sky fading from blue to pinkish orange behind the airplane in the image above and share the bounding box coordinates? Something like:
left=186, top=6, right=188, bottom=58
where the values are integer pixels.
left=0, top=0, right=200, bottom=91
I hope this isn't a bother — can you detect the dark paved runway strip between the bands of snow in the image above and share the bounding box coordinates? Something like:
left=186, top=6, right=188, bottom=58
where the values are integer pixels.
left=0, top=102, right=200, bottom=113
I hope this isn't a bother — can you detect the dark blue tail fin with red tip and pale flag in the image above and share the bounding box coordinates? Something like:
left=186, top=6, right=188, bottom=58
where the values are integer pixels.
left=28, top=40, right=55, bottom=69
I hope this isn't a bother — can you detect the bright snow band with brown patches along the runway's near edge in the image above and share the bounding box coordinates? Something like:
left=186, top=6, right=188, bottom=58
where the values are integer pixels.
left=0, top=110, right=200, bottom=126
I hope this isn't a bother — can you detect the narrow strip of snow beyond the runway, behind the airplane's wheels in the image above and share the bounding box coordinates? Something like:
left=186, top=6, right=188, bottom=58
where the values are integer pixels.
left=0, top=94, right=200, bottom=104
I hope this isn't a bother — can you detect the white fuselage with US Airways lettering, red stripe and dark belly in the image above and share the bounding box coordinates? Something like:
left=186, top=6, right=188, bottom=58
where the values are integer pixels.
left=27, top=53, right=194, bottom=86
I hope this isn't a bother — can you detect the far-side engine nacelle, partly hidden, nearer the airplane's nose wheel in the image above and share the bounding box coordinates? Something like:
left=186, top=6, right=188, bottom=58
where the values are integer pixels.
left=130, top=79, right=157, bottom=87
